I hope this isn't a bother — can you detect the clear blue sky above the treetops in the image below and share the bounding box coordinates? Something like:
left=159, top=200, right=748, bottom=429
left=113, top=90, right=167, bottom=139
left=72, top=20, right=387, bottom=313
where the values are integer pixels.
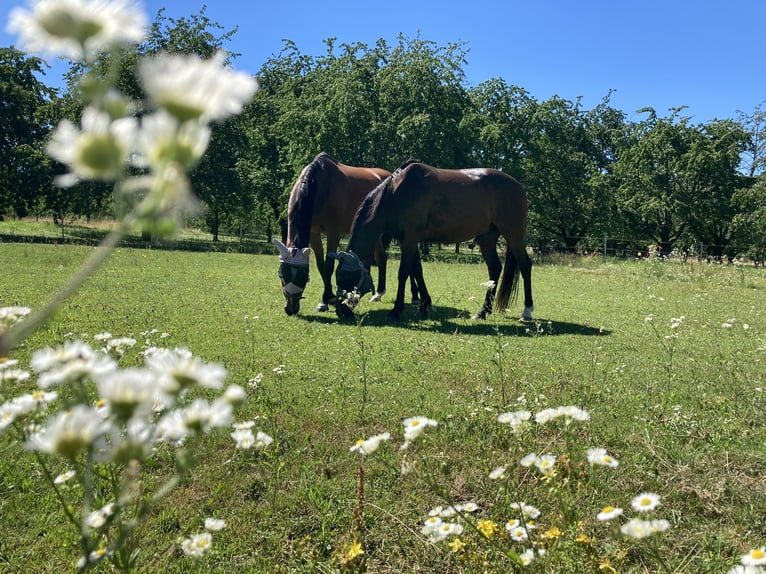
left=0, top=0, right=766, bottom=123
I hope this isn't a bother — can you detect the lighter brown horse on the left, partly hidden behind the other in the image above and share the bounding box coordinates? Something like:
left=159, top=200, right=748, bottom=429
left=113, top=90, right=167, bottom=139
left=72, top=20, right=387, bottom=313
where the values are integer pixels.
left=274, top=152, right=420, bottom=315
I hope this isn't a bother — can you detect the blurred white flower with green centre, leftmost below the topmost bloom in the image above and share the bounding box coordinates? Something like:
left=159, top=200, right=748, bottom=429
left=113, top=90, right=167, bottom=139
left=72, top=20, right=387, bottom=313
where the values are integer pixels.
left=47, top=107, right=138, bottom=187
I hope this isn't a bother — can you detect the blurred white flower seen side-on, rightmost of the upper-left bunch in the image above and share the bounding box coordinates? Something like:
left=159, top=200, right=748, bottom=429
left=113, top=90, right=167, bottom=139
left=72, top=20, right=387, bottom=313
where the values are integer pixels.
left=138, top=52, right=258, bottom=122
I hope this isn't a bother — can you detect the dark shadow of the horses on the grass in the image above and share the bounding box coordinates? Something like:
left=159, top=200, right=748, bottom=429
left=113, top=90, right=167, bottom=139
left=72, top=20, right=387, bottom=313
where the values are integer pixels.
left=296, top=305, right=611, bottom=337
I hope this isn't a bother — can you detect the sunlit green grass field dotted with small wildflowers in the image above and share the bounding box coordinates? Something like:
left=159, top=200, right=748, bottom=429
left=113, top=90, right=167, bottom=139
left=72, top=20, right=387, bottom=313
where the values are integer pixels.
left=0, top=244, right=766, bottom=573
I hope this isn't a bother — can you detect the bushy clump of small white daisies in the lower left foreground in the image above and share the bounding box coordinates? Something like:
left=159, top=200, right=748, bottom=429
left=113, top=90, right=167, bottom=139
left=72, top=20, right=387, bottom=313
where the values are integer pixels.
left=0, top=328, right=272, bottom=569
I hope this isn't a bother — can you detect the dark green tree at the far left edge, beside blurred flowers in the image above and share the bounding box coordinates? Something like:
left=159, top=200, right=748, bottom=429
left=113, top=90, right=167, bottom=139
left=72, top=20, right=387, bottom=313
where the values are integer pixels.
left=0, top=47, right=56, bottom=217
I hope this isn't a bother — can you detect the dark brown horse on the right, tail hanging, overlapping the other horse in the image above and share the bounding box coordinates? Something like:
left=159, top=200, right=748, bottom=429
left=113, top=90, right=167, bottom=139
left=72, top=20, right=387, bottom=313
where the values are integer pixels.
left=336, top=162, right=533, bottom=321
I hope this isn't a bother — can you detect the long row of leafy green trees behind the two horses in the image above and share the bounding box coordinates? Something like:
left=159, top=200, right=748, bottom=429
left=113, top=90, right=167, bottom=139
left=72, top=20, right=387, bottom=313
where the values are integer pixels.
left=0, top=7, right=766, bottom=255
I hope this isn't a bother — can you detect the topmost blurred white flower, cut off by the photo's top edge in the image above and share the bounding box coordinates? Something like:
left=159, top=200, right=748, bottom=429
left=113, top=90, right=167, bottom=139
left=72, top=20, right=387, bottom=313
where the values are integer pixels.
left=7, top=0, right=146, bottom=59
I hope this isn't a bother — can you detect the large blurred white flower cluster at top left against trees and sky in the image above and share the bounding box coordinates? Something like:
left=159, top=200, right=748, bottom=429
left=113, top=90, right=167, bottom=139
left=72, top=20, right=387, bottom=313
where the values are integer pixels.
left=8, top=0, right=257, bottom=241
